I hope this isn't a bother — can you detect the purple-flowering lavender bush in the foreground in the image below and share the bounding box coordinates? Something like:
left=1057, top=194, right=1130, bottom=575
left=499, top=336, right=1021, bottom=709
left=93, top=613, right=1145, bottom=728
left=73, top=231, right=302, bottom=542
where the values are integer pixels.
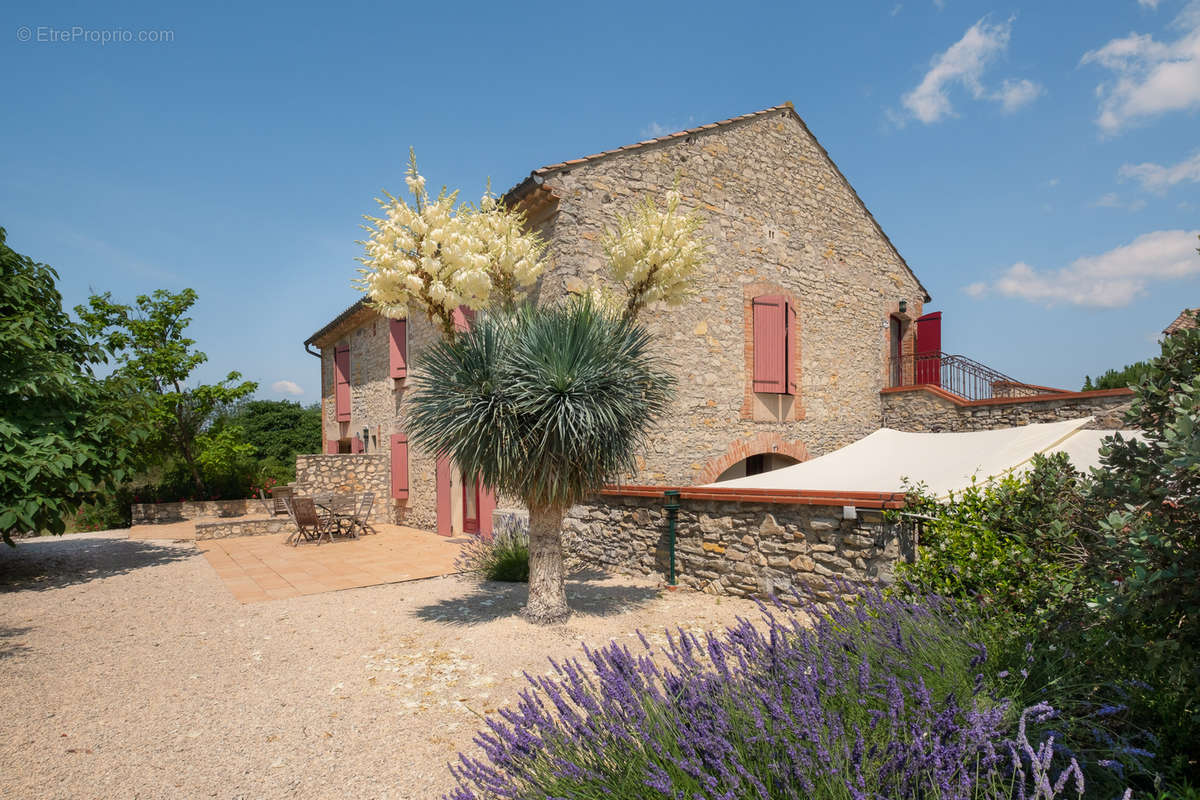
left=448, top=591, right=1082, bottom=800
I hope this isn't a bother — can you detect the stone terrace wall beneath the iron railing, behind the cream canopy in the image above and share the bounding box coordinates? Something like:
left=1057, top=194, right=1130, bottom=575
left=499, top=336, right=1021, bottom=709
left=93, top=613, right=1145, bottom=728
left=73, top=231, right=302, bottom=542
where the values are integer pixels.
left=880, top=386, right=1133, bottom=433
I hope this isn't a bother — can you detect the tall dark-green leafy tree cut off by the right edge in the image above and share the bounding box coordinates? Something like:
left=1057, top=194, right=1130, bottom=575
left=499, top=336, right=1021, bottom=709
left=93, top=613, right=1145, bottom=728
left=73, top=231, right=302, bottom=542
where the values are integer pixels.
left=1092, top=309, right=1200, bottom=780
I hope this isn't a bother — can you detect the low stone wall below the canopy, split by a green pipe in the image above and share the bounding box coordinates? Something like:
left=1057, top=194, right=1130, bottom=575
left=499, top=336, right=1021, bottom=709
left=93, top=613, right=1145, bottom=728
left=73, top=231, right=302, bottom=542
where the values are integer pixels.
left=563, top=495, right=911, bottom=600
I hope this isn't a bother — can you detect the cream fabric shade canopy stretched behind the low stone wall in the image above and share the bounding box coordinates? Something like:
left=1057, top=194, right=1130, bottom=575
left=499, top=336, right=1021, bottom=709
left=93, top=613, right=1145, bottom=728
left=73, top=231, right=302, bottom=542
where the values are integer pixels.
left=708, top=416, right=1132, bottom=498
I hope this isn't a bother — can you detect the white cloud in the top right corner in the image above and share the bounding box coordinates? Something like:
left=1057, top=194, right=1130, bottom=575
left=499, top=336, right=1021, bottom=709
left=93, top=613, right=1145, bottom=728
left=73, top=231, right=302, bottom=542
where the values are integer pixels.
left=1080, top=0, right=1200, bottom=134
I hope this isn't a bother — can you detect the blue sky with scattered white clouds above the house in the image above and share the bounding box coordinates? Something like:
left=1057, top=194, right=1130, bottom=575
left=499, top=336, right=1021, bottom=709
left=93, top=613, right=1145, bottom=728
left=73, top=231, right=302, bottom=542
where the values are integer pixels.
left=0, top=0, right=1200, bottom=402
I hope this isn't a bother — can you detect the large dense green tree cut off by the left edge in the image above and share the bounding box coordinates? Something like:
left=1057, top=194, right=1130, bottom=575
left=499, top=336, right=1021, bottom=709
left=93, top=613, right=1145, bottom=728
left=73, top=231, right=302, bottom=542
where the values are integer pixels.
left=0, top=228, right=144, bottom=545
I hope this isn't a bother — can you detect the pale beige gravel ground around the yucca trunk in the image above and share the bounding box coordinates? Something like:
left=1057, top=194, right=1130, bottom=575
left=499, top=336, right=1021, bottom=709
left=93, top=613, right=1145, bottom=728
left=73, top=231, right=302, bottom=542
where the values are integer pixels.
left=0, top=533, right=757, bottom=800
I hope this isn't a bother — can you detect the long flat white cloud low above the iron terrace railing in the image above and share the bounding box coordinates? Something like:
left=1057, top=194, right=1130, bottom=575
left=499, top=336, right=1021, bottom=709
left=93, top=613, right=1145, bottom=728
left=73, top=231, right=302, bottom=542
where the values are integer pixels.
left=964, top=230, right=1200, bottom=308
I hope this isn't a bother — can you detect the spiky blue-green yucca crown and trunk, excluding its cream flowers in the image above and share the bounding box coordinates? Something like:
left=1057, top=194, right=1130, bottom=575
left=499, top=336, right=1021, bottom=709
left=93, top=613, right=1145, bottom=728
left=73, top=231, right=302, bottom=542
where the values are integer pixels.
left=407, top=299, right=674, bottom=624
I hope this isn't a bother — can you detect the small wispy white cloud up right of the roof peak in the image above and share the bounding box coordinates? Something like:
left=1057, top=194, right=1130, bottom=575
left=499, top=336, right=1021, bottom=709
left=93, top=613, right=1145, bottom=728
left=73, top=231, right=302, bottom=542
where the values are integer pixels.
left=900, top=17, right=1042, bottom=125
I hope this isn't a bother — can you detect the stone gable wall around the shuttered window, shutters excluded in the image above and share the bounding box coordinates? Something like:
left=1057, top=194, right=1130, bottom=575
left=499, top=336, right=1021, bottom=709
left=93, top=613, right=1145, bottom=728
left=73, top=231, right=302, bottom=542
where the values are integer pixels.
left=530, top=109, right=924, bottom=485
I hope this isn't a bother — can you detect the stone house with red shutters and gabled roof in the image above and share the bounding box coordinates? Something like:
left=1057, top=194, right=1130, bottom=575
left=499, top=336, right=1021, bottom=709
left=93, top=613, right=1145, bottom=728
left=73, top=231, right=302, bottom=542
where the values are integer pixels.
left=305, top=103, right=1128, bottom=546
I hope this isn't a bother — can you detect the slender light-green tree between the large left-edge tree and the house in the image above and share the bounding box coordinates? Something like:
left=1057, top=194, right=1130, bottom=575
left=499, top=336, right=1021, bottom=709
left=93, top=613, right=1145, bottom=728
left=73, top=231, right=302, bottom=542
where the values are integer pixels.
left=76, top=289, right=258, bottom=495
